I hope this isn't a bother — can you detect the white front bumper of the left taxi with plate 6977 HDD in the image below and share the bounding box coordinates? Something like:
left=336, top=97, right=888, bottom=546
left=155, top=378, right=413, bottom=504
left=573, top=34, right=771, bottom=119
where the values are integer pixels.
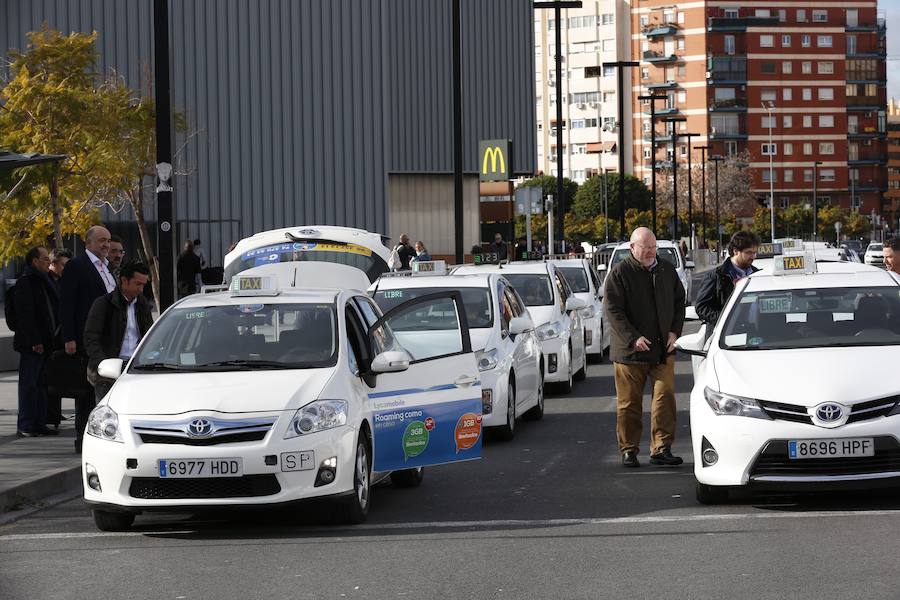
left=81, top=415, right=358, bottom=512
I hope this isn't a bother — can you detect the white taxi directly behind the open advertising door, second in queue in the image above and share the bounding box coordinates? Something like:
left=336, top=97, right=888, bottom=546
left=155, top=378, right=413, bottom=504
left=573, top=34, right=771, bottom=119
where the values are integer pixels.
left=369, top=268, right=544, bottom=440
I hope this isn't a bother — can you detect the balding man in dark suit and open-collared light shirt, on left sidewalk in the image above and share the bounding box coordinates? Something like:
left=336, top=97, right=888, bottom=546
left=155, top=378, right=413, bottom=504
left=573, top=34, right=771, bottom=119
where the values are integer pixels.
left=59, top=225, right=116, bottom=453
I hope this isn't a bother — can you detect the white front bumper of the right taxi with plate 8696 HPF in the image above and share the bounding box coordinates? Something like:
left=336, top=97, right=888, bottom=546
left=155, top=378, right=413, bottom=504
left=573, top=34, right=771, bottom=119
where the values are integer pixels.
left=690, top=389, right=900, bottom=491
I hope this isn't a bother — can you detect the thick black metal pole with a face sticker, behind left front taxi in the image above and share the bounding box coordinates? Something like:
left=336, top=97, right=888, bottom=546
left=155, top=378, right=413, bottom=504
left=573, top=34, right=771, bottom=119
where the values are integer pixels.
left=153, top=0, right=175, bottom=311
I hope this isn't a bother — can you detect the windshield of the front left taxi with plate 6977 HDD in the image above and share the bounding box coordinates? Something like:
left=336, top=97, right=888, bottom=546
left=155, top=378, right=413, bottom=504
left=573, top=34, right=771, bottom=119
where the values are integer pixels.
left=131, top=301, right=337, bottom=372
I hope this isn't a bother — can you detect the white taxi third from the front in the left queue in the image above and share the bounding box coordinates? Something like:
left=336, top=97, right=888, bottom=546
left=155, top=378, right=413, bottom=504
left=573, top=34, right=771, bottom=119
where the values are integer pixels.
left=453, top=261, right=586, bottom=393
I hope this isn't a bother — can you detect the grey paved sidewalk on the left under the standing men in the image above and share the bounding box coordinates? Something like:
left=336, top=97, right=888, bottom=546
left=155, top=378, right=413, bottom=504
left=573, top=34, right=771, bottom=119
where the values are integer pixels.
left=0, top=371, right=81, bottom=520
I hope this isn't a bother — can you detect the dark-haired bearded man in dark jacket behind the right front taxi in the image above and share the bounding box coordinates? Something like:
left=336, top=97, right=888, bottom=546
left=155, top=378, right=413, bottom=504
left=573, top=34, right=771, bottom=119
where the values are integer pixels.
left=694, top=231, right=759, bottom=332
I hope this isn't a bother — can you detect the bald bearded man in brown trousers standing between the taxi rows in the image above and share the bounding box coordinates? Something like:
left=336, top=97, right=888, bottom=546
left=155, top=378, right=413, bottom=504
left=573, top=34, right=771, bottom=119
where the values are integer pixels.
left=603, top=227, right=684, bottom=467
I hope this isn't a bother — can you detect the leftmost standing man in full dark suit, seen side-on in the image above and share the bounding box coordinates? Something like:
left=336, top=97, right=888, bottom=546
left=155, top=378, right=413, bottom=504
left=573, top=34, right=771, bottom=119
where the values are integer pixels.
left=13, top=246, right=59, bottom=437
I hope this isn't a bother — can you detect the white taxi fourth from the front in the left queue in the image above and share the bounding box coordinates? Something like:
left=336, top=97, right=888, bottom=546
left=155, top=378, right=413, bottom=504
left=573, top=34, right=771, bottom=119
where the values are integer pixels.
left=548, top=257, right=609, bottom=360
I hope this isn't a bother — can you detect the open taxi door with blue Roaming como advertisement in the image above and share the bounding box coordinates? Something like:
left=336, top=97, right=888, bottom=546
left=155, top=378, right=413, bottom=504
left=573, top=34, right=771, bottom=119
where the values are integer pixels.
left=367, top=290, right=482, bottom=472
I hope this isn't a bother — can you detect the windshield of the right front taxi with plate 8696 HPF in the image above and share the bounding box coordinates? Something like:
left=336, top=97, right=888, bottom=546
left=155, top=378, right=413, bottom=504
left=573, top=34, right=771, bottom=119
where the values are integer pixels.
left=720, top=287, right=900, bottom=350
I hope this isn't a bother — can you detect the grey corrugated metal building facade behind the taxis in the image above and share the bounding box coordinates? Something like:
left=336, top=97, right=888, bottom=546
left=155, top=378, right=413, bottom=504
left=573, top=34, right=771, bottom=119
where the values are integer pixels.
left=0, top=0, right=536, bottom=264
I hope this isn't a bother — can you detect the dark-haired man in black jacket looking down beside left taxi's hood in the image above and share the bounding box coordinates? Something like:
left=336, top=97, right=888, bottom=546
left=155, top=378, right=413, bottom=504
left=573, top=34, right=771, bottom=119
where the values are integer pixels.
left=84, top=262, right=153, bottom=401
